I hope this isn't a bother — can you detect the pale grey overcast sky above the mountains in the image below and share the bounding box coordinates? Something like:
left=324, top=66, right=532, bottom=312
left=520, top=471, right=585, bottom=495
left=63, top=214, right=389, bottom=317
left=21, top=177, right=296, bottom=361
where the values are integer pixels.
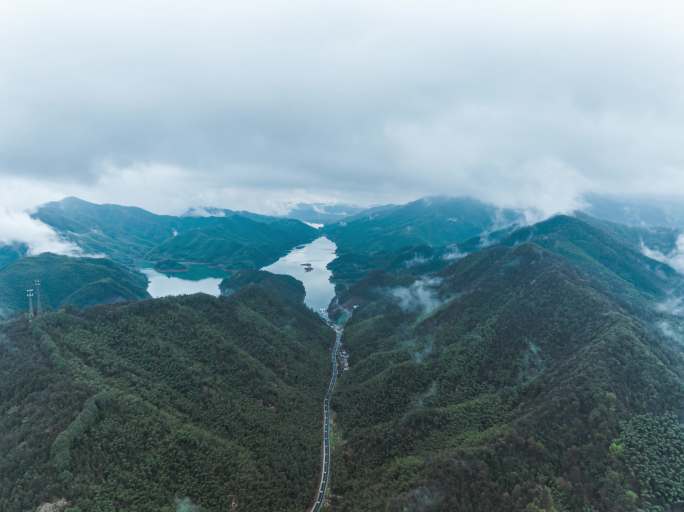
left=0, top=0, right=684, bottom=226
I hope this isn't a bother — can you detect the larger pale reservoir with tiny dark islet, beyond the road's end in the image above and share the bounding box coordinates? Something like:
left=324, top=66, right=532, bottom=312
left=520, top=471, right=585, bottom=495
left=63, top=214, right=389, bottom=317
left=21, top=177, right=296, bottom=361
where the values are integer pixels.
left=262, top=236, right=337, bottom=312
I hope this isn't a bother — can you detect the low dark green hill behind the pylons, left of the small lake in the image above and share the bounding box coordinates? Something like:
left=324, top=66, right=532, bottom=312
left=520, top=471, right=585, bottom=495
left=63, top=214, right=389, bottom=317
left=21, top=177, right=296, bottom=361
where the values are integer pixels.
left=0, top=253, right=149, bottom=316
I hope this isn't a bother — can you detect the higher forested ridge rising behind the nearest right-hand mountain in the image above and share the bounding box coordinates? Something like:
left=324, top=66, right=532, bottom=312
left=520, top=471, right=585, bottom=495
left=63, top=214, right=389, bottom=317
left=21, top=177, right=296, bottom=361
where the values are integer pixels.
left=330, top=214, right=684, bottom=316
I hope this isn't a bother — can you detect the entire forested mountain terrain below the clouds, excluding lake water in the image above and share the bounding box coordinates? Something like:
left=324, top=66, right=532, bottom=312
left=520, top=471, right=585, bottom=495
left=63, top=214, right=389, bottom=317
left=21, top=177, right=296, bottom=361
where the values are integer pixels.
left=0, top=197, right=684, bottom=512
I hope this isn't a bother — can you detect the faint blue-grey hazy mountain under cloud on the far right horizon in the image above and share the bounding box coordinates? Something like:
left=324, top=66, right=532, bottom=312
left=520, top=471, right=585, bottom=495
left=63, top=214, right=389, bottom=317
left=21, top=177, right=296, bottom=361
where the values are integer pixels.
left=583, top=195, right=684, bottom=228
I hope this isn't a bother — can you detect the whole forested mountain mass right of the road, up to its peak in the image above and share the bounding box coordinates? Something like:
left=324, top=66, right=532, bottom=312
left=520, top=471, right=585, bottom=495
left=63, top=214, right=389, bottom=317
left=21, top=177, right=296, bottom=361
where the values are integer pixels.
left=332, top=217, right=684, bottom=512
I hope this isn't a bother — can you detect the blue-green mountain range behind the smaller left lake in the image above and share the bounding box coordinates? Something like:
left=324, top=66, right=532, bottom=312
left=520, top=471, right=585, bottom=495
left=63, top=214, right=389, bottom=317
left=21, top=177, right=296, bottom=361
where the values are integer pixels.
left=35, top=198, right=318, bottom=270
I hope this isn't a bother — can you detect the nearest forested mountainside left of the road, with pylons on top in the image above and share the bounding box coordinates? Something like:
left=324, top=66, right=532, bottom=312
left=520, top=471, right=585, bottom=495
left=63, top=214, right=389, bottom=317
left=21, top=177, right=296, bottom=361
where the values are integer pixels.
left=0, top=286, right=334, bottom=512
